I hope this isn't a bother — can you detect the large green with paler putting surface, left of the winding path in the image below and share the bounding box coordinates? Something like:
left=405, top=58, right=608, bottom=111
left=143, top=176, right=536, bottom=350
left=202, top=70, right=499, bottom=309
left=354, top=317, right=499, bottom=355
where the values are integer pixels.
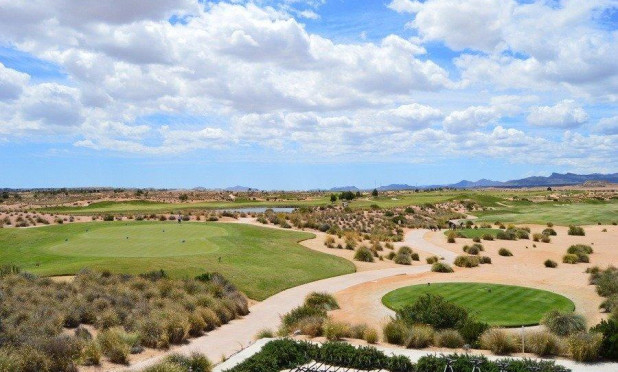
left=0, top=222, right=355, bottom=300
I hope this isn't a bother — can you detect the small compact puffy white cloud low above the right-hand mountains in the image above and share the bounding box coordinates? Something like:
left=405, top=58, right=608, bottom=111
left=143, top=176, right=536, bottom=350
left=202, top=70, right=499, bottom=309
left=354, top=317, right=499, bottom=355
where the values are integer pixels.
left=528, top=100, right=588, bottom=128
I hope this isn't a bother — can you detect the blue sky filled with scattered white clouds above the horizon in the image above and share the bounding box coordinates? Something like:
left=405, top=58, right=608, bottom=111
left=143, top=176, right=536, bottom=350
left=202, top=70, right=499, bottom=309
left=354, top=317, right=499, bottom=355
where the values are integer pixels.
left=0, top=0, right=618, bottom=190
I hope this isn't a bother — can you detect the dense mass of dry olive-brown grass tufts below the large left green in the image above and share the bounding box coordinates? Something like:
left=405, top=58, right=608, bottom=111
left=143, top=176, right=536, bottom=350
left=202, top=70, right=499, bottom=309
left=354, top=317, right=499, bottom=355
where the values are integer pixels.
left=0, top=267, right=244, bottom=372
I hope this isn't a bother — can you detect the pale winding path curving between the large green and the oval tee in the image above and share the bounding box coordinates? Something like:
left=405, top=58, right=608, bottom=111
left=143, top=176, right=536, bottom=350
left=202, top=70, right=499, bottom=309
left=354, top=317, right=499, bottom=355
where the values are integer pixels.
left=118, top=230, right=454, bottom=370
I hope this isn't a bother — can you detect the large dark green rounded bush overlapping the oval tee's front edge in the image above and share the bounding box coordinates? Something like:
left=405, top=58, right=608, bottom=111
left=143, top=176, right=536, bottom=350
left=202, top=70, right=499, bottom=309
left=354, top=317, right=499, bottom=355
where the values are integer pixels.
left=397, top=294, right=468, bottom=330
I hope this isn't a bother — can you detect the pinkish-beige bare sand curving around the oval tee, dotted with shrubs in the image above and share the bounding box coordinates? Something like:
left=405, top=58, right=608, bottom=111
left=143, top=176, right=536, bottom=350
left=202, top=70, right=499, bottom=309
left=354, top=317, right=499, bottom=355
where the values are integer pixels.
left=332, top=225, right=618, bottom=325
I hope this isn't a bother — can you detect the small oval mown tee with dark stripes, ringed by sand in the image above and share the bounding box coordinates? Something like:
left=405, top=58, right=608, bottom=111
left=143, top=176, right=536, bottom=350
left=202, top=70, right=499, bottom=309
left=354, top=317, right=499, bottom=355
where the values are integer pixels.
left=382, top=283, right=575, bottom=327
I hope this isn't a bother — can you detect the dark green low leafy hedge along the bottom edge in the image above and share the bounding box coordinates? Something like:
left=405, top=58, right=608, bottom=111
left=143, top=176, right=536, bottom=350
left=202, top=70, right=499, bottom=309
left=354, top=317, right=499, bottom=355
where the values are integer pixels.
left=221, top=339, right=569, bottom=372
